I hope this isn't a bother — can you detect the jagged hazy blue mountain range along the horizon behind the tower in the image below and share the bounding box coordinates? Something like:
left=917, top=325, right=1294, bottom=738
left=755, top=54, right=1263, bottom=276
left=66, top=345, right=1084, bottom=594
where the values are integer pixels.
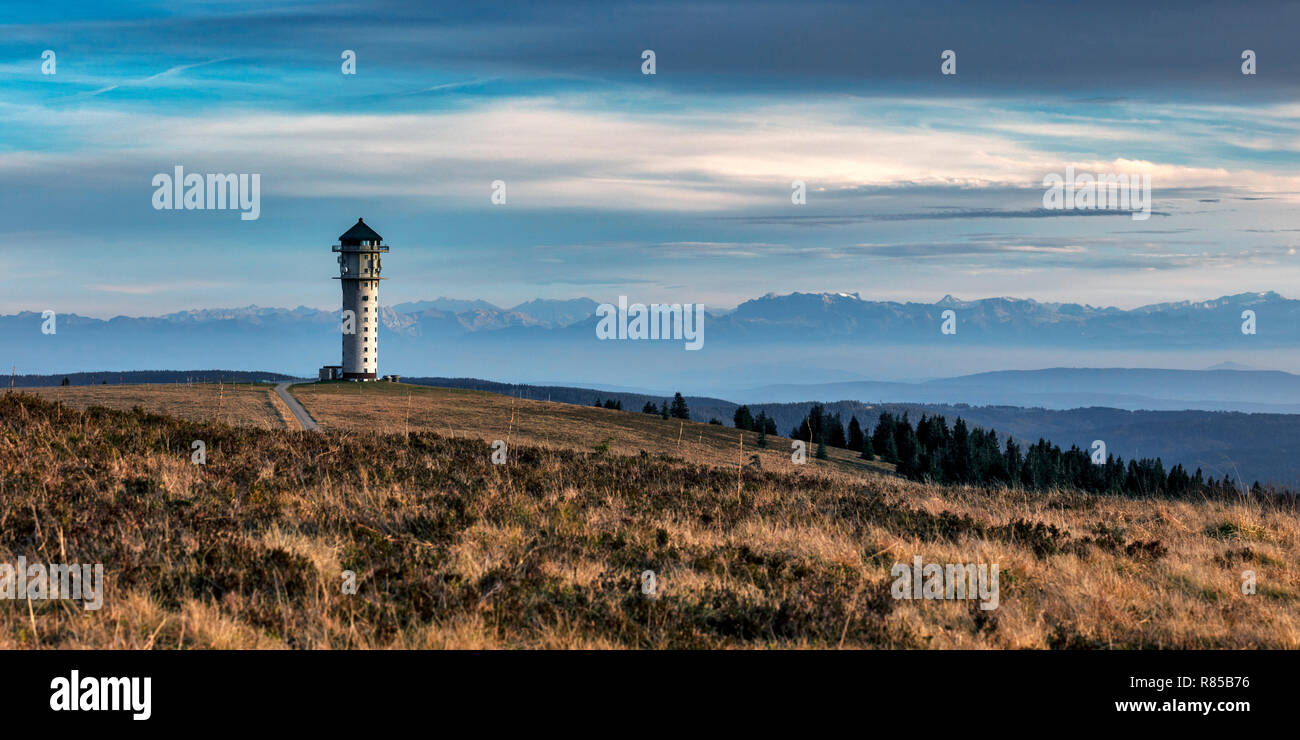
left=0, top=293, right=1300, bottom=392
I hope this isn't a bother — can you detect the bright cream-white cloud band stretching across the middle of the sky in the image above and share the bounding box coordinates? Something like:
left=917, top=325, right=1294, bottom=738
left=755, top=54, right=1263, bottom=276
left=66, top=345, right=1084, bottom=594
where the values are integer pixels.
left=10, top=94, right=1300, bottom=210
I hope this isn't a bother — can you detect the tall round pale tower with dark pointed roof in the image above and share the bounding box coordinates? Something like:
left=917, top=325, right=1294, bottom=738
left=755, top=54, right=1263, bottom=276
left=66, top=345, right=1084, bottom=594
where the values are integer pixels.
left=332, top=218, right=389, bottom=380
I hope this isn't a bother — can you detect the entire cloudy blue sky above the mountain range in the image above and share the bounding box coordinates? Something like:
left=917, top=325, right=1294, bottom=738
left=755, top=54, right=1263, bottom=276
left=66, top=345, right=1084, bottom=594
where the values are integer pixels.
left=0, top=1, right=1300, bottom=317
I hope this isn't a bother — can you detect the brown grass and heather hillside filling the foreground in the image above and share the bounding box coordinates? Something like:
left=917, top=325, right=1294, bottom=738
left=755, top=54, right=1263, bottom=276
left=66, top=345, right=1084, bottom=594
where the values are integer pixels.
left=0, top=384, right=1300, bottom=649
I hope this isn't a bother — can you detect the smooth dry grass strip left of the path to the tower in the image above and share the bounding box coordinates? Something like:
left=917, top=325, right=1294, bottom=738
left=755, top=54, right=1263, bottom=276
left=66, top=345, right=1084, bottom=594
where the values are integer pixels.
left=21, top=382, right=289, bottom=429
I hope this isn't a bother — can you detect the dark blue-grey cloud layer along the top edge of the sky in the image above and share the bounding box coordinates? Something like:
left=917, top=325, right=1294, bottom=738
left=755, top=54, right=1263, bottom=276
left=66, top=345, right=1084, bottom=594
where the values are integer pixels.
left=15, top=0, right=1300, bottom=99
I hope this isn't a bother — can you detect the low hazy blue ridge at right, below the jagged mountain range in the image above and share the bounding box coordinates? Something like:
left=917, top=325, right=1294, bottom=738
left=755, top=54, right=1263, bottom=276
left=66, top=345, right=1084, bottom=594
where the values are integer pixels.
left=736, top=368, right=1300, bottom=414
